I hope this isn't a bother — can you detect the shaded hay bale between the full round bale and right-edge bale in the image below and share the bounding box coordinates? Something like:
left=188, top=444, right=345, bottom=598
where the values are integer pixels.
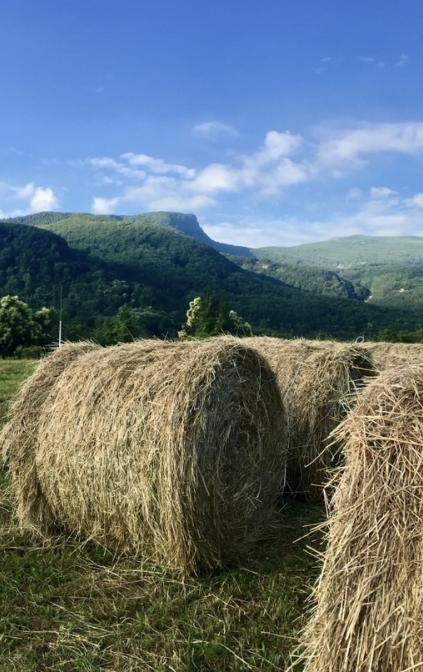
left=243, top=337, right=373, bottom=502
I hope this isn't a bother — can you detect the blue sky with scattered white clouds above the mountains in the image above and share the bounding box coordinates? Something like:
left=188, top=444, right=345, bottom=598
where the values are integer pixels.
left=0, top=0, right=423, bottom=246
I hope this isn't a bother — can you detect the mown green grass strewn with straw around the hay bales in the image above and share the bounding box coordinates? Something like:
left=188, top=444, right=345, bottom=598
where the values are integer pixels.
left=0, top=361, right=322, bottom=672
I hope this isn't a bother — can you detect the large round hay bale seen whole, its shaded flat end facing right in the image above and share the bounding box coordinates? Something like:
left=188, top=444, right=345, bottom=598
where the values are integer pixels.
left=6, top=340, right=287, bottom=574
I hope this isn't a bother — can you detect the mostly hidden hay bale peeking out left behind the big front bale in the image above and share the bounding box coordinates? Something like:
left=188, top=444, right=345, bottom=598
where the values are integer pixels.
left=0, top=341, right=99, bottom=530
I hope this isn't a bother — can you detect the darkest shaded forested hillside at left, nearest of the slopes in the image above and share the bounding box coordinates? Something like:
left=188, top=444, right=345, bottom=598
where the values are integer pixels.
left=0, top=222, right=176, bottom=338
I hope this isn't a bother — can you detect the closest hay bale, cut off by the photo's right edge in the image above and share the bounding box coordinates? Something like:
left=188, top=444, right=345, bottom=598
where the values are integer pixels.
left=304, top=367, right=423, bottom=672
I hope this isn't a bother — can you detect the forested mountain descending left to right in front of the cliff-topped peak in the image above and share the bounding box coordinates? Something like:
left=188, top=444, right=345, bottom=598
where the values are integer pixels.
left=0, top=215, right=418, bottom=338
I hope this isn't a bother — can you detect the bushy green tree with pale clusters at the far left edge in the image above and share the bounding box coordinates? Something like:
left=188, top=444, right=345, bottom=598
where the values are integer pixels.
left=0, top=295, right=52, bottom=357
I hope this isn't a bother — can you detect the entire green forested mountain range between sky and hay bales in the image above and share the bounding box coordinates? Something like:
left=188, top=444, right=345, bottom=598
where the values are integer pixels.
left=0, top=212, right=423, bottom=338
